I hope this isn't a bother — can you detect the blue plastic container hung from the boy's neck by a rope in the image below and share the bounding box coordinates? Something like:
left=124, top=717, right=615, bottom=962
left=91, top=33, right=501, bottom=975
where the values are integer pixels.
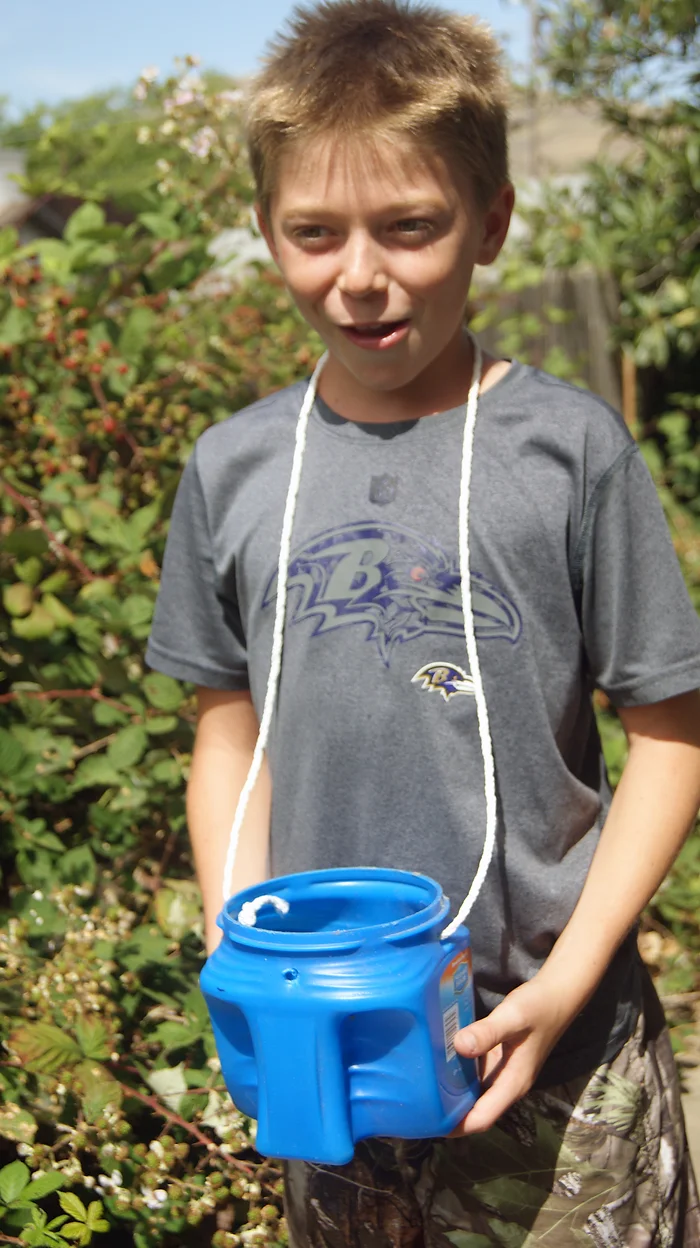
left=201, top=867, right=479, bottom=1166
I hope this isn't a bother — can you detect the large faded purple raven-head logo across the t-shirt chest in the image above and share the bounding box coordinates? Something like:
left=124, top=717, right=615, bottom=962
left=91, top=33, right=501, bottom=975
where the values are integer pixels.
left=262, top=520, right=523, bottom=668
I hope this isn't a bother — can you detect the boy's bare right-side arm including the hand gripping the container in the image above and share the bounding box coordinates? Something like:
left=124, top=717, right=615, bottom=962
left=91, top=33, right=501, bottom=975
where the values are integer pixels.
left=454, top=691, right=700, bottom=1134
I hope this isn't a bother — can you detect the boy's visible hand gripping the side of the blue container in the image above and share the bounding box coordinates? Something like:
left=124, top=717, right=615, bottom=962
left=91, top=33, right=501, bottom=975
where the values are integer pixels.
left=452, top=978, right=575, bottom=1136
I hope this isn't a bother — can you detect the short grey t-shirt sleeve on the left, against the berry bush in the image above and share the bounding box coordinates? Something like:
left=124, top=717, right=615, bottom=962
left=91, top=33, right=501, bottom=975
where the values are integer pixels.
left=146, top=448, right=248, bottom=690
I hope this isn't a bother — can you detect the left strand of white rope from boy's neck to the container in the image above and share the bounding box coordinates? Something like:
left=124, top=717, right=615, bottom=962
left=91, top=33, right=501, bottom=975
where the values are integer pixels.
left=223, top=354, right=328, bottom=902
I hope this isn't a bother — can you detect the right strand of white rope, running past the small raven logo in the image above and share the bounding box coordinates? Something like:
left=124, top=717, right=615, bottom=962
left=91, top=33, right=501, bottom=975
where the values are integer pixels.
left=440, top=337, right=497, bottom=940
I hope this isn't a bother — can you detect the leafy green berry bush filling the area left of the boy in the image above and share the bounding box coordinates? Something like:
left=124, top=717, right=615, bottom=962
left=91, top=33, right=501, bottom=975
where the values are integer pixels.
left=0, top=60, right=317, bottom=1248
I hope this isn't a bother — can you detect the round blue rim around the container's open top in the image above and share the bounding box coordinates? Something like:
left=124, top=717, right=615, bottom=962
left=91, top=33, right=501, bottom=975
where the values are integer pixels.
left=218, top=867, right=449, bottom=952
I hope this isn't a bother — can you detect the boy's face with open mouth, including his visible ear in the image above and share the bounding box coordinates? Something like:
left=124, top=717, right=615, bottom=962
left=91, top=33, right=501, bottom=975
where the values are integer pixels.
left=260, top=139, right=513, bottom=409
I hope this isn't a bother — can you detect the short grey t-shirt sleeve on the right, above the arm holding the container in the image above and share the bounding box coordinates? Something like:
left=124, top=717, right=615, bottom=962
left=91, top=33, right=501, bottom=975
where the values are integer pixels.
left=578, top=446, right=700, bottom=706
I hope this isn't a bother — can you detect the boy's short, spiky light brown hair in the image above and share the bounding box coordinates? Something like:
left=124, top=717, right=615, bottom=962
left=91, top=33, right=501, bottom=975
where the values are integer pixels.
left=247, top=0, right=508, bottom=216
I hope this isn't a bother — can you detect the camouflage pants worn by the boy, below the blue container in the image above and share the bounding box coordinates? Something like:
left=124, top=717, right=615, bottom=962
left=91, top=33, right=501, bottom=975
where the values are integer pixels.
left=286, top=983, right=700, bottom=1248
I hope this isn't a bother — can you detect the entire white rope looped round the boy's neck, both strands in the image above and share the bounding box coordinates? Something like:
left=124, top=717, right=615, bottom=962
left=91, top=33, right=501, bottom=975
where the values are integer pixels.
left=223, top=338, right=497, bottom=940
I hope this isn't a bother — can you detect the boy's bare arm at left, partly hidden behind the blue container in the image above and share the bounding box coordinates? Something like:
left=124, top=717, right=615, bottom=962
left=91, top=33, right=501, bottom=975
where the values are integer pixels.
left=187, top=688, right=271, bottom=953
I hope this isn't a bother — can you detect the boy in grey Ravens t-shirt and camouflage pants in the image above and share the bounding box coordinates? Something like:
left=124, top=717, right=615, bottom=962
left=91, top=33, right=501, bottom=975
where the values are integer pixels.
left=147, top=0, right=700, bottom=1248
